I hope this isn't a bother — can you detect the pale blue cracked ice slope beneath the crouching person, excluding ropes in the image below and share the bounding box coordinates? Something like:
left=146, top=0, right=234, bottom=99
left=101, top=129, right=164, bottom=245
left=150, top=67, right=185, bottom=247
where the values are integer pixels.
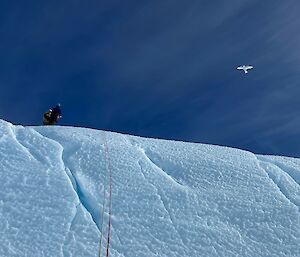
left=0, top=120, right=300, bottom=257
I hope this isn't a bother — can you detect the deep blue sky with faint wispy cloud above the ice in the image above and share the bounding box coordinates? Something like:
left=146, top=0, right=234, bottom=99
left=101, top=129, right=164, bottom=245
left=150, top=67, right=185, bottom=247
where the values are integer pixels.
left=0, top=0, right=300, bottom=157
